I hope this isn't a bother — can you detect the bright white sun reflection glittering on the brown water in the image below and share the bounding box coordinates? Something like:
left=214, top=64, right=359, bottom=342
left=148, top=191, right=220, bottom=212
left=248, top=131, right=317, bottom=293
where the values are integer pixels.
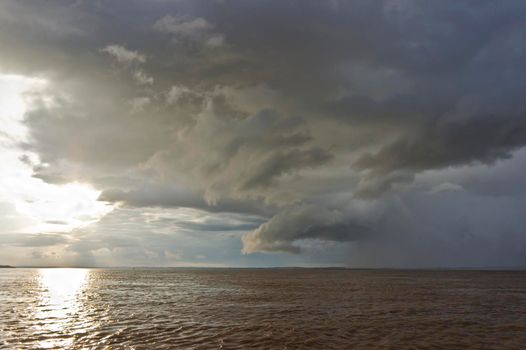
left=35, top=269, right=90, bottom=348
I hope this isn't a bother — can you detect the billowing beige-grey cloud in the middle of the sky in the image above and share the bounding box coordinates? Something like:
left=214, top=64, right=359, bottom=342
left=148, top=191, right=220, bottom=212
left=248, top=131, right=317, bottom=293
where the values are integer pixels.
left=142, top=107, right=332, bottom=203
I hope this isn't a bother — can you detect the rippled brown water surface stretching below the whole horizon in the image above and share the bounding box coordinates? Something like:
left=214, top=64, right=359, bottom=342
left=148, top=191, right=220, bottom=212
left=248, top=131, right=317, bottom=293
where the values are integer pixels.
left=0, top=269, right=526, bottom=349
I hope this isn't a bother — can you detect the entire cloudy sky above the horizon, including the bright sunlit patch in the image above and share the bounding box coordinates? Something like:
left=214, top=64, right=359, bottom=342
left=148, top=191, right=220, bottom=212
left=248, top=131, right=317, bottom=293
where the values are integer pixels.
left=0, top=0, right=526, bottom=268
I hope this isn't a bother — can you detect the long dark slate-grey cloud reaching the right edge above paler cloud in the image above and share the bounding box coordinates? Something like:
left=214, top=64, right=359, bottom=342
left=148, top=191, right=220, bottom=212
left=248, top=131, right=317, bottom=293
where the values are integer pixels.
left=354, top=115, right=526, bottom=174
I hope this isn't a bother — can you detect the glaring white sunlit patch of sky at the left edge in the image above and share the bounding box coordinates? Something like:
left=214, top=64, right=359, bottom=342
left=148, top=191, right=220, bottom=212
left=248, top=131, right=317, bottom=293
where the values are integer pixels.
left=0, top=75, right=113, bottom=237
